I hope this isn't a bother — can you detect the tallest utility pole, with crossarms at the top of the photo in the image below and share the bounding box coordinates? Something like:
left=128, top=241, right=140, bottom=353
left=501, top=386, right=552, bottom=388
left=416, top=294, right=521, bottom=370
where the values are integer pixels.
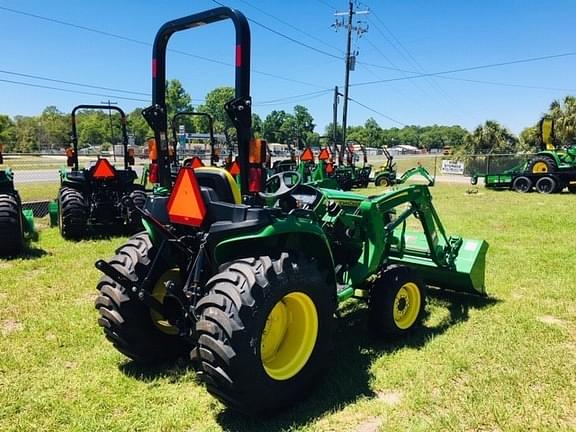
left=332, top=0, right=370, bottom=164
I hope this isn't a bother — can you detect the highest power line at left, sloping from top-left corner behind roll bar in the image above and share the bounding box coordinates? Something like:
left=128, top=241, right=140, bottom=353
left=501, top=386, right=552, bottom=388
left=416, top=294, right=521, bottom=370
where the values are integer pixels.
left=0, top=6, right=328, bottom=88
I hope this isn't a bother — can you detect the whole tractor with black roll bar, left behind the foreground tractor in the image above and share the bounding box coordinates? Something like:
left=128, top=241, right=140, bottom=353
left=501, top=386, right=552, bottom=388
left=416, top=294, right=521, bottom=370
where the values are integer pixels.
left=51, top=105, right=146, bottom=240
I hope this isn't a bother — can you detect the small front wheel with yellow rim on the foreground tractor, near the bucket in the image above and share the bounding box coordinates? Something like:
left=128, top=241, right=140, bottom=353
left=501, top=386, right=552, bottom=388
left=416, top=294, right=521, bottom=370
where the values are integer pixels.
left=369, top=266, right=426, bottom=338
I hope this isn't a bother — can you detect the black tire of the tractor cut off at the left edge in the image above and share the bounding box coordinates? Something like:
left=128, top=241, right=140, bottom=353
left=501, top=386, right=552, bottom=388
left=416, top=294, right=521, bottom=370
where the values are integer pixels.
left=0, top=194, right=24, bottom=256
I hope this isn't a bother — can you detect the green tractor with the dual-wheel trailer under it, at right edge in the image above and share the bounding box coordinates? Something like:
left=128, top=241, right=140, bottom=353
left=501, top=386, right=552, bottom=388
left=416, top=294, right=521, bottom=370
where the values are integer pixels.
left=470, top=117, right=576, bottom=194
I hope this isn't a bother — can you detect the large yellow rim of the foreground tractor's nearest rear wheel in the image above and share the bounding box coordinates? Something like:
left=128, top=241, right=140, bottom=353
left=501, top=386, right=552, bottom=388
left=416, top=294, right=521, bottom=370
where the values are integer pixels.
left=260, top=292, right=318, bottom=381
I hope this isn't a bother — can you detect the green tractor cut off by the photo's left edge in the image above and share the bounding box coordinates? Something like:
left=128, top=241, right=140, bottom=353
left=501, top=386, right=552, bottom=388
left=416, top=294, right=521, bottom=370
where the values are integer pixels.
left=0, top=148, right=37, bottom=257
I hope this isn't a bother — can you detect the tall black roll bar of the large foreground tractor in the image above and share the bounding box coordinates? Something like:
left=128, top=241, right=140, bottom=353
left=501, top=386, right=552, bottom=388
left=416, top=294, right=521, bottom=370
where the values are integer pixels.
left=142, top=7, right=252, bottom=194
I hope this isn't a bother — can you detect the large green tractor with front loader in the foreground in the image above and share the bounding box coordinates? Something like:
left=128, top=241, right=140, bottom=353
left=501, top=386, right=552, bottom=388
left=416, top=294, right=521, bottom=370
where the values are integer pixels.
left=96, top=7, right=488, bottom=414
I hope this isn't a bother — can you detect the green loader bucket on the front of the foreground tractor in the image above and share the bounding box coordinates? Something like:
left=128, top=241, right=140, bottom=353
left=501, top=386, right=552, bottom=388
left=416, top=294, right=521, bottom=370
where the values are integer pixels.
left=390, top=232, right=488, bottom=295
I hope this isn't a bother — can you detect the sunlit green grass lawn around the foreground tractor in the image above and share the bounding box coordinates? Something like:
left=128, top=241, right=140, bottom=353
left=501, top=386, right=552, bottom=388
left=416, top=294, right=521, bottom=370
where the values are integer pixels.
left=0, top=184, right=576, bottom=432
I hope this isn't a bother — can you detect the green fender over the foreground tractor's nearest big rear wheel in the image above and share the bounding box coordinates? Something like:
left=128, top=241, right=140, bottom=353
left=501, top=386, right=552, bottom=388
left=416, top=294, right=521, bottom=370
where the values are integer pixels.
left=212, top=216, right=336, bottom=283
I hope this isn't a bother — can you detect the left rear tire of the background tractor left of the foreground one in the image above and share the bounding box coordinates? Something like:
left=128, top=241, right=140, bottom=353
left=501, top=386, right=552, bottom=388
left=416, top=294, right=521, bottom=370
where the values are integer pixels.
left=58, top=187, right=88, bottom=240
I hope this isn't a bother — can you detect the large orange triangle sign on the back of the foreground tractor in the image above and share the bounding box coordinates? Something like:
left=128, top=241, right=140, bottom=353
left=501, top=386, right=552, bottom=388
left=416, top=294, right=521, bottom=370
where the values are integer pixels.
left=168, top=167, right=206, bottom=227
